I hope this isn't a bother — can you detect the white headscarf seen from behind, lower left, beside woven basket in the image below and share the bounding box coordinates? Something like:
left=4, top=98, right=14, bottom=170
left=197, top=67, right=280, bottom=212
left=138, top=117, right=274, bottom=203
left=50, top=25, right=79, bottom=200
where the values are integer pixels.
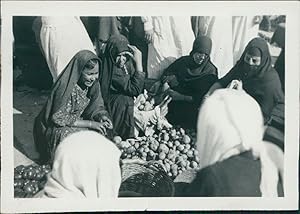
left=44, top=131, right=121, bottom=198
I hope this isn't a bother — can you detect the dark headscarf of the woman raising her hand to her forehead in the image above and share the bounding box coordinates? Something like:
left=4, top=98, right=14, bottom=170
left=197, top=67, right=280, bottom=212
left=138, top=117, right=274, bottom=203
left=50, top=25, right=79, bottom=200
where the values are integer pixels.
left=99, top=35, right=129, bottom=102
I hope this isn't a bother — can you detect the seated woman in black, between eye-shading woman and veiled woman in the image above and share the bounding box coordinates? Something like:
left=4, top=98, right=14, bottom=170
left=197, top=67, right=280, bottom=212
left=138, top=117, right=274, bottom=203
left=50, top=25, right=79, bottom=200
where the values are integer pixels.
left=154, top=36, right=218, bottom=128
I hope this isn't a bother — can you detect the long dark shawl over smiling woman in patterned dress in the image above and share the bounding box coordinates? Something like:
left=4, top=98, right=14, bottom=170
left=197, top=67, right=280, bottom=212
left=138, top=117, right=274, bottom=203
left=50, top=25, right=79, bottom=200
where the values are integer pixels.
left=33, top=50, right=108, bottom=162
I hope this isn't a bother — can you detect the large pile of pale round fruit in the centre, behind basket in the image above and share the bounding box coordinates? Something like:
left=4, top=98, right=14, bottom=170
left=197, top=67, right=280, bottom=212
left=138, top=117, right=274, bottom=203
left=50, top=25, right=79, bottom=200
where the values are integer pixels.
left=114, top=127, right=199, bottom=179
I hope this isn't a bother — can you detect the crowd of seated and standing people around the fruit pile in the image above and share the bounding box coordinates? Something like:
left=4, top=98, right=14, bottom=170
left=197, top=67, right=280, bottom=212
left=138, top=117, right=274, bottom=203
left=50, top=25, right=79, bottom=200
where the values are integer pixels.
left=26, top=16, right=284, bottom=197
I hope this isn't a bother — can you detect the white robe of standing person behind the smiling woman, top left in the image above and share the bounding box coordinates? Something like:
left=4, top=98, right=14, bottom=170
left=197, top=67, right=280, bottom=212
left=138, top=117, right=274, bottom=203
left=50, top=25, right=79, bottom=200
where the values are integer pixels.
left=37, top=16, right=96, bottom=82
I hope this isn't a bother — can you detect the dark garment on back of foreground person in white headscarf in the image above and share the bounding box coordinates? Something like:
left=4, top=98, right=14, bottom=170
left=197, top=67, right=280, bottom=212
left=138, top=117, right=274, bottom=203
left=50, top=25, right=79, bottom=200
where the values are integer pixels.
left=175, top=152, right=283, bottom=197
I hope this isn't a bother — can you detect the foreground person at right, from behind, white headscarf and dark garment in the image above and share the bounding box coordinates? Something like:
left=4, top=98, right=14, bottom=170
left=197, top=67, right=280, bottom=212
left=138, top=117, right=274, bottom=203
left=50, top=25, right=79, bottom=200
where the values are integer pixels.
left=181, top=89, right=283, bottom=197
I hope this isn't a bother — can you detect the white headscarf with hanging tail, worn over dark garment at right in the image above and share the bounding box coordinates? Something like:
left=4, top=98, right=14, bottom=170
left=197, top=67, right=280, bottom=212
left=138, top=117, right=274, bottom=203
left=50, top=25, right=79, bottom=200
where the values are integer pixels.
left=197, top=89, right=278, bottom=196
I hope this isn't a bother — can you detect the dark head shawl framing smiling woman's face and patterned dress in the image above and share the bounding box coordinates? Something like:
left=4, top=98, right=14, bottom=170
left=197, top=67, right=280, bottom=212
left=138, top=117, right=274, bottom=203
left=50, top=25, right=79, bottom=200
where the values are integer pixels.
left=34, top=50, right=107, bottom=156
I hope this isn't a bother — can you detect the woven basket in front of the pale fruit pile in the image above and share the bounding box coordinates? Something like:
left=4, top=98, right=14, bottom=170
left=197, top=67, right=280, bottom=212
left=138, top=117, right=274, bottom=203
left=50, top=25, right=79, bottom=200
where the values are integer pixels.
left=120, top=161, right=175, bottom=197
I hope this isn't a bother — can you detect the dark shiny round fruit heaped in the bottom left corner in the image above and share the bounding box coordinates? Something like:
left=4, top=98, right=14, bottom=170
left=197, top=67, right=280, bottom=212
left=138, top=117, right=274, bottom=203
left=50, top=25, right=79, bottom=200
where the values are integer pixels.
left=14, top=164, right=51, bottom=198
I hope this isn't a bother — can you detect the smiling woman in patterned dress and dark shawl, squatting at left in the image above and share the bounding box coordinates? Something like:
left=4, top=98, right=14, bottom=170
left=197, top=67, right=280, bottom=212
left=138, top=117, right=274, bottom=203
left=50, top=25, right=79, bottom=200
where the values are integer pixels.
left=33, top=50, right=112, bottom=162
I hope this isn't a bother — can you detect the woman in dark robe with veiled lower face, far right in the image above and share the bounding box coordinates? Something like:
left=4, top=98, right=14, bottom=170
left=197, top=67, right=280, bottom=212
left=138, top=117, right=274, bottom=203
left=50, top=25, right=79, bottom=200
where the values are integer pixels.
left=207, top=38, right=284, bottom=123
